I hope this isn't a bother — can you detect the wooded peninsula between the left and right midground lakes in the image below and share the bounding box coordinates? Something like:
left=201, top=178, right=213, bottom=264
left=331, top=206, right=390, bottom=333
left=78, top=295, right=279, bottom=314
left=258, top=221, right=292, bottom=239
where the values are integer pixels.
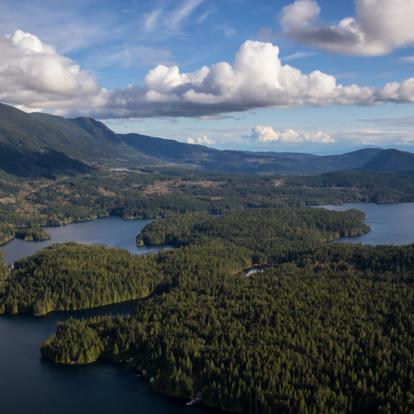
left=137, top=208, right=369, bottom=261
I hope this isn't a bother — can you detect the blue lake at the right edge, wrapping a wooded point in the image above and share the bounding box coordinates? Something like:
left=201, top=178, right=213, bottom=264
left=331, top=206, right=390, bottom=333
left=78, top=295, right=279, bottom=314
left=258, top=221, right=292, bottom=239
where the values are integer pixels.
left=323, top=203, right=414, bottom=245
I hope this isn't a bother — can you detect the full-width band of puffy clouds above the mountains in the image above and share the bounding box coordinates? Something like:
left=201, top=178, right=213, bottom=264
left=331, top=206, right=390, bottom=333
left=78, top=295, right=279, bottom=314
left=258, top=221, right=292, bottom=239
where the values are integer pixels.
left=0, top=29, right=414, bottom=119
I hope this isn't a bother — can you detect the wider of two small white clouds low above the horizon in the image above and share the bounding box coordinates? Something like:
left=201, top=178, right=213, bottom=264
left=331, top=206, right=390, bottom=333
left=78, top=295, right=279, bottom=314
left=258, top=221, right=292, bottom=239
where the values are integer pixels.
left=250, top=125, right=335, bottom=144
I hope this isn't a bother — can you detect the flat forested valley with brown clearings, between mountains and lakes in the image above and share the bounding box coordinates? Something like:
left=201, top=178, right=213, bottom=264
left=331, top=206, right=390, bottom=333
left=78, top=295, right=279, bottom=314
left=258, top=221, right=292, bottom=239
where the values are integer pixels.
left=0, top=169, right=414, bottom=243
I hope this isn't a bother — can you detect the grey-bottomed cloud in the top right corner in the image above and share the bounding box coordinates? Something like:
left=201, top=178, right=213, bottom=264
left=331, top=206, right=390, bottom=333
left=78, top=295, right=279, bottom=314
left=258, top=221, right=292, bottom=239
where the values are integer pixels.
left=280, top=0, right=414, bottom=56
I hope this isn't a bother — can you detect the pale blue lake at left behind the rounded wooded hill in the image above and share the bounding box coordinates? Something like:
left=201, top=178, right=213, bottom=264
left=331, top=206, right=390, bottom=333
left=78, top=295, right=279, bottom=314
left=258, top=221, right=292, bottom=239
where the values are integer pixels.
left=2, top=217, right=163, bottom=264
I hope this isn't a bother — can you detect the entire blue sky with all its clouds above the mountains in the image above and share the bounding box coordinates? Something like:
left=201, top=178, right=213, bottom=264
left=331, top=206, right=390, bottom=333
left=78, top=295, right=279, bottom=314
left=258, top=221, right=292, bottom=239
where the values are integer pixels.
left=0, top=0, right=414, bottom=154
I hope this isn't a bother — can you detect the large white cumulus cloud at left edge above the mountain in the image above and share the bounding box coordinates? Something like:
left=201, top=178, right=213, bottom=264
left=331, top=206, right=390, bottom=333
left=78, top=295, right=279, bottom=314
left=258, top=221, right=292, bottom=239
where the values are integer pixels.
left=0, top=30, right=103, bottom=110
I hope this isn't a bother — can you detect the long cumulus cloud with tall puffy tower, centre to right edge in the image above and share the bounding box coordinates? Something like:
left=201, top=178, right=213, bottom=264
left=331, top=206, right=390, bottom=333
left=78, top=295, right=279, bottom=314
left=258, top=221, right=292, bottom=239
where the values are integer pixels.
left=103, top=40, right=414, bottom=117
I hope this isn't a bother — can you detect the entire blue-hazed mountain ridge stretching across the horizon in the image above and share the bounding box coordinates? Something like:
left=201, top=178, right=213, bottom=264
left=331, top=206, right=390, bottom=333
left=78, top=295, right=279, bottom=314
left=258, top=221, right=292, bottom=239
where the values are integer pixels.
left=0, top=104, right=414, bottom=176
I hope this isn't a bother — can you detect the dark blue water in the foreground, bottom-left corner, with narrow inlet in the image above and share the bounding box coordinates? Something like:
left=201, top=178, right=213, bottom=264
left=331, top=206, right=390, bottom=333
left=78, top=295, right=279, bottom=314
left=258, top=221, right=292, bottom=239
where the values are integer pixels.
left=0, top=303, right=213, bottom=414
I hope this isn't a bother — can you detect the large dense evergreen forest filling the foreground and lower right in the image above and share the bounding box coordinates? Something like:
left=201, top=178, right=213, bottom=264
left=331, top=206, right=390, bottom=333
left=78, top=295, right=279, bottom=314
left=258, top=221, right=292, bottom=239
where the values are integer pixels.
left=42, top=245, right=414, bottom=414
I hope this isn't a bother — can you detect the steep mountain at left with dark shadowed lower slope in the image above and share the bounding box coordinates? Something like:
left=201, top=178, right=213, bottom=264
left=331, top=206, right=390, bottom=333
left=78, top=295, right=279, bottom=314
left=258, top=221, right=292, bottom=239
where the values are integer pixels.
left=0, top=104, right=154, bottom=176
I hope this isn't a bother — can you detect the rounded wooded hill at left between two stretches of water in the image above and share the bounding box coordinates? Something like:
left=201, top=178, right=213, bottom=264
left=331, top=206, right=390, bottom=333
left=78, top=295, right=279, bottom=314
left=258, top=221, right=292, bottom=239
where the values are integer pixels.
left=0, top=243, right=162, bottom=315
